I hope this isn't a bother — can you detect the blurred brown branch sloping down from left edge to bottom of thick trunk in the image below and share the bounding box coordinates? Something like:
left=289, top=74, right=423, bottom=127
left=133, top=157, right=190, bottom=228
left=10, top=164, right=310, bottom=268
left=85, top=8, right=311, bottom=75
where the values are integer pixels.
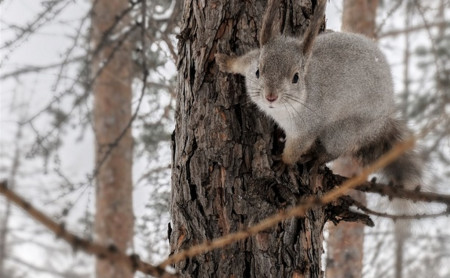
left=0, top=181, right=178, bottom=278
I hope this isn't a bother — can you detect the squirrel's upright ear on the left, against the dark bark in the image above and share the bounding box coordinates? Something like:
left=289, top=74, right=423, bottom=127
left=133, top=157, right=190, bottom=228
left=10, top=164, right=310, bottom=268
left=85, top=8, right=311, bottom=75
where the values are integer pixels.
left=259, top=0, right=281, bottom=48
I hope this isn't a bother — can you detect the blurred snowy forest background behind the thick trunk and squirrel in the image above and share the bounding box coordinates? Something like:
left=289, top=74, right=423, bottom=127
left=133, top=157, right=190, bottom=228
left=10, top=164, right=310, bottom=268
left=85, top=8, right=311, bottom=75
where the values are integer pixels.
left=0, top=0, right=450, bottom=278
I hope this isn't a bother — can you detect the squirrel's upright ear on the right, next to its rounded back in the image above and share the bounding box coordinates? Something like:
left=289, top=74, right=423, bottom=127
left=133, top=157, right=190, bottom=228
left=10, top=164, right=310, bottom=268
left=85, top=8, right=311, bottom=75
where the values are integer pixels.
left=302, top=0, right=327, bottom=59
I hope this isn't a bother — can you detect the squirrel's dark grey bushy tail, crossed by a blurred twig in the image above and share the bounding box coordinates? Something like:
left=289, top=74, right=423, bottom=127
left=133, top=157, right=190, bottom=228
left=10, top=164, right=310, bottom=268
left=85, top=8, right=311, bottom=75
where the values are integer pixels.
left=356, top=119, right=423, bottom=190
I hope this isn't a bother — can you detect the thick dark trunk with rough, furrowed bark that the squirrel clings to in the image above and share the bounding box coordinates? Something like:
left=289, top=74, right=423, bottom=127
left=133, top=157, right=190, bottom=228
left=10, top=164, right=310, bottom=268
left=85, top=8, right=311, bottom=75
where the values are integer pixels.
left=169, top=0, right=326, bottom=277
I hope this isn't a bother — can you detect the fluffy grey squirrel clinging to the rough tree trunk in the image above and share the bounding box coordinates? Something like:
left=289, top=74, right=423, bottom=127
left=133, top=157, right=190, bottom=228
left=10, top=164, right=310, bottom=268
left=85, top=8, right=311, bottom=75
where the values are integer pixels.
left=216, top=0, right=422, bottom=189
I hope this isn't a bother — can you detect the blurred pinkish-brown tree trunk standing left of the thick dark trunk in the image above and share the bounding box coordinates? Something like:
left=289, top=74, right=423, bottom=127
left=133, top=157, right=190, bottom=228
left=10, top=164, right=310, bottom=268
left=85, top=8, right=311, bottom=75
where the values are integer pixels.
left=92, top=0, right=134, bottom=278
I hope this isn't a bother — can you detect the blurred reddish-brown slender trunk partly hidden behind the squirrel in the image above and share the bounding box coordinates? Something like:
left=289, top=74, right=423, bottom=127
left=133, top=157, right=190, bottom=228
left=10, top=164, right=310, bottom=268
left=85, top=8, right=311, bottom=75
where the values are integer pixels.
left=326, top=0, right=378, bottom=278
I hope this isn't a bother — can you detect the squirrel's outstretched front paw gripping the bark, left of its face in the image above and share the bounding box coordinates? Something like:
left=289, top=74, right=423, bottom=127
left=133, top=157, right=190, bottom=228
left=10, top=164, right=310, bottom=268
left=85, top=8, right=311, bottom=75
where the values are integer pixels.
left=215, top=49, right=259, bottom=75
